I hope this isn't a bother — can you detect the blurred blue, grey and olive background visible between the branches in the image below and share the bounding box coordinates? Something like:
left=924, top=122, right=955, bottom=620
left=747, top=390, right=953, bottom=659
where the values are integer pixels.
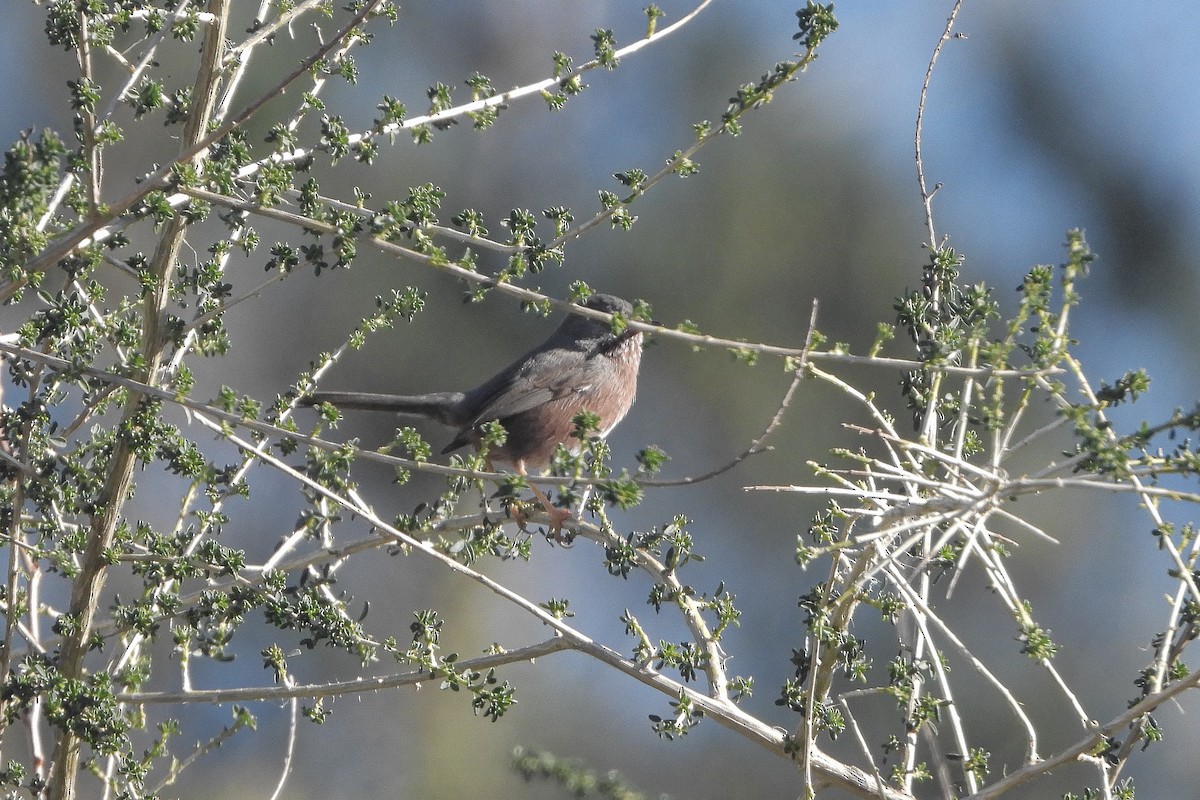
left=0, top=0, right=1200, bottom=799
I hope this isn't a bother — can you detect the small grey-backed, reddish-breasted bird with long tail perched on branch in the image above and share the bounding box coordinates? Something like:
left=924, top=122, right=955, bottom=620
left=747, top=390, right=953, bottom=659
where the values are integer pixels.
left=300, top=293, right=643, bottom=536
